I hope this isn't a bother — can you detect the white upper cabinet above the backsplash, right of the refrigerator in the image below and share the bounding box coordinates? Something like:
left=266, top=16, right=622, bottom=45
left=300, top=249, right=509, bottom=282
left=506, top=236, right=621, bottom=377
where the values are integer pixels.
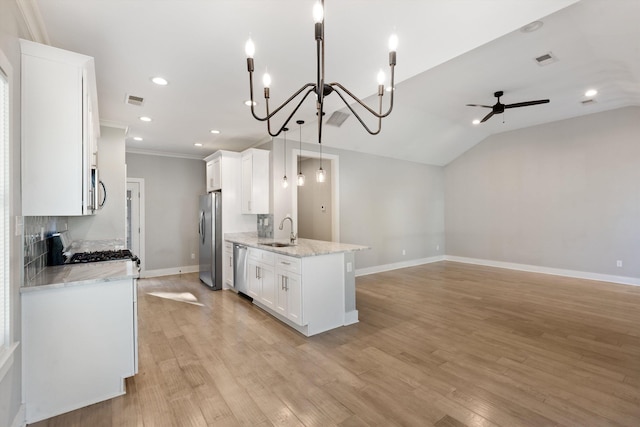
left=241, top=148, right=269, bottom=214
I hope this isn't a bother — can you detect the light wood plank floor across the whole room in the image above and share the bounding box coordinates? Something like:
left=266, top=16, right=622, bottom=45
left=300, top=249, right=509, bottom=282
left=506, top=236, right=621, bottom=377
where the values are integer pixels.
left=28, top=262, right=640, bottom=427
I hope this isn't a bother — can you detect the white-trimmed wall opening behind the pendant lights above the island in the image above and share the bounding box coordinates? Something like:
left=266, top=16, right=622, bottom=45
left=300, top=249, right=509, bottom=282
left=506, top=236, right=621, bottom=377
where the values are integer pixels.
left=290, top=150, right=340, bottom=242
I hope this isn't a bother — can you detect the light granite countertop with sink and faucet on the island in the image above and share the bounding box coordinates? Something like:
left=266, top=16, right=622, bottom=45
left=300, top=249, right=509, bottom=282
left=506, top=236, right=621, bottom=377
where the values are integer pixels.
left=224, top=232, right=371, bottom=258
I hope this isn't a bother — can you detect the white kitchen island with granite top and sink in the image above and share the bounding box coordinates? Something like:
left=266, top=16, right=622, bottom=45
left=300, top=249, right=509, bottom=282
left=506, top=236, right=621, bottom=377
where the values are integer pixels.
left=224, top=232, right=369, bottom=336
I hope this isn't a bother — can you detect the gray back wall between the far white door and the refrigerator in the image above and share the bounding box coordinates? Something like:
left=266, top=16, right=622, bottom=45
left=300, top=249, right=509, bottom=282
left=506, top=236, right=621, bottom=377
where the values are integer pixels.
left=126, top=153, right=206, bottom=271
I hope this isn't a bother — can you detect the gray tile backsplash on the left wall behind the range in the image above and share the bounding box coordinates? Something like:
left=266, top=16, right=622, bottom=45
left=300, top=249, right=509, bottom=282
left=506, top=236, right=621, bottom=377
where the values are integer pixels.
left=23, top=216, right=67, bottom=283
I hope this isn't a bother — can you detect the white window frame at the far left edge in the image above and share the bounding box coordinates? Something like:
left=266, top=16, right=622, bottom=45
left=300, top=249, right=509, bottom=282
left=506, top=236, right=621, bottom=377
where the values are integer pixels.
left=0, top=45, right=18, bottom=381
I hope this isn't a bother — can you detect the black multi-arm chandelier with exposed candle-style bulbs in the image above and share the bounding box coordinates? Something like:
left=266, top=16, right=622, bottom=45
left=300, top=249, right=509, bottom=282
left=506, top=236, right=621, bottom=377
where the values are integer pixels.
left=245, top=0, right=398, bottom=145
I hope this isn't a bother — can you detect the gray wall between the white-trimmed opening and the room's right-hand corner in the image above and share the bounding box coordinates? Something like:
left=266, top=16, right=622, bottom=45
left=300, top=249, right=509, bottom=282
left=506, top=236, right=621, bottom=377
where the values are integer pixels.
left=340, top=150, right=445, bottom=269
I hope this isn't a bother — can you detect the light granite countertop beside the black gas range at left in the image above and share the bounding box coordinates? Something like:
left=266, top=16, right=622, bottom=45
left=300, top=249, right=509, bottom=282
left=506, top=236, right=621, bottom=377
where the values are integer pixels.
left=20, top=260, right=139, bottom=293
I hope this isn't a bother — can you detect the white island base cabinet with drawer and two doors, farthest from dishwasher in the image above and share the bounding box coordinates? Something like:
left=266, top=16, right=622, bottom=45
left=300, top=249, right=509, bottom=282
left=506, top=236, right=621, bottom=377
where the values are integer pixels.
left=274, top=255, right=304, bottom=325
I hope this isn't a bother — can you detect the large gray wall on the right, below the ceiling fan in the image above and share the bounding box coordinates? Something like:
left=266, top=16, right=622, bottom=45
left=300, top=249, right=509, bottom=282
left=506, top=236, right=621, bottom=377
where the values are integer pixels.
left=445, top=107, right=640, bottom=277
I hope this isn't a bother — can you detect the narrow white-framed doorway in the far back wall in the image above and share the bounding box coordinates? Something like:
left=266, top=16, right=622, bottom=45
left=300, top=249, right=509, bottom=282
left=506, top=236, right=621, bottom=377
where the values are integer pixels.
left=126, top=178, right=145, bottom=271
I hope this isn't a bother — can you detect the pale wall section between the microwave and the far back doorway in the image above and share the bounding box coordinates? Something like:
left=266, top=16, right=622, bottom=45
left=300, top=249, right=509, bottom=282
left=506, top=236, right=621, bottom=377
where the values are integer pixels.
left=69, top=126, right=127, bottom=240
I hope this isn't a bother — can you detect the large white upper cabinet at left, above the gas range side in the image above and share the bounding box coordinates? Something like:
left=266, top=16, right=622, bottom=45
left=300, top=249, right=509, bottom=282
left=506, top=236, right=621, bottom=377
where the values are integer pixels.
left=20, top=40, right=100, bottom=216
